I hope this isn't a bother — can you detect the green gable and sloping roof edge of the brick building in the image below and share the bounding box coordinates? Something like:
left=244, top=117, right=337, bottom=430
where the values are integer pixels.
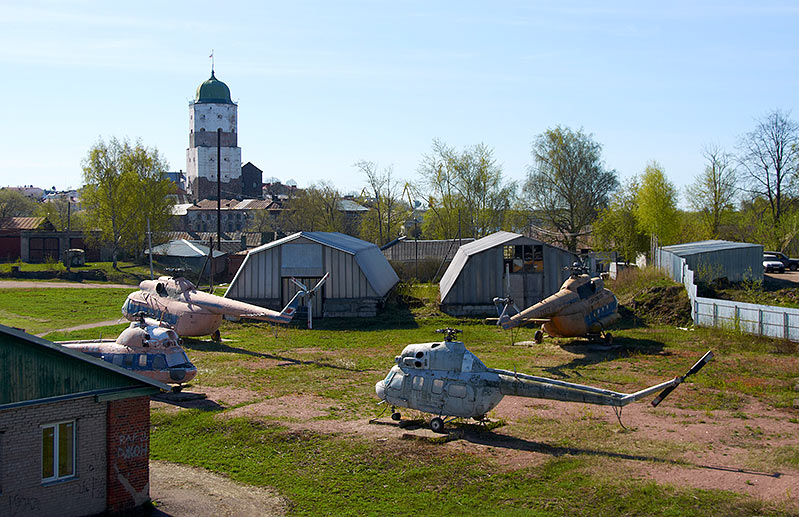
left=0, top=325, right=169, bottom=410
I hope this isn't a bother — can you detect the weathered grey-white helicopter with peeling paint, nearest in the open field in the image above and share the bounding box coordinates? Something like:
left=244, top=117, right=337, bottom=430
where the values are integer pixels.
left=375, top=328, right=713, bottom=433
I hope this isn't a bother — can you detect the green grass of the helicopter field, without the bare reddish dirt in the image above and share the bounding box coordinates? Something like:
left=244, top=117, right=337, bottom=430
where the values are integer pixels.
left=14, top=287, right=799, bottom=516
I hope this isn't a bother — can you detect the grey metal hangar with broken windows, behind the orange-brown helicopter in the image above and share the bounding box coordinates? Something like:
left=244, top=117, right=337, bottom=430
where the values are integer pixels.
left=439, top=232, right=577, bottom=316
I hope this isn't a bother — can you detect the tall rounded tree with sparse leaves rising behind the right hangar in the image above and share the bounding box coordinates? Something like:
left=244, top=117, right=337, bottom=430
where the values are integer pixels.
left=524, top=126, right=619, bottom=251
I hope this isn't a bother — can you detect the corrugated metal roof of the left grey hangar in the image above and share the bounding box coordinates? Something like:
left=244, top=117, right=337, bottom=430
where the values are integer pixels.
left=245, top=232, right=399, bottom=296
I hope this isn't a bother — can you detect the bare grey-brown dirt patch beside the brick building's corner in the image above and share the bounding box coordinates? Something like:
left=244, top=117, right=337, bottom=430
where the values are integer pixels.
left=150, top=461, right=289, bottom=517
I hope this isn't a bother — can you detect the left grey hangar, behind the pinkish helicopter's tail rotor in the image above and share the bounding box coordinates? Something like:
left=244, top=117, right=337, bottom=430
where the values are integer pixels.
left=225, top=232, right=399, bottom=317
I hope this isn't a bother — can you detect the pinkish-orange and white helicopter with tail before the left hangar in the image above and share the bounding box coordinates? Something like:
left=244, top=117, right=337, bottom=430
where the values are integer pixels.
left=122, top=273, right=330, bottom=341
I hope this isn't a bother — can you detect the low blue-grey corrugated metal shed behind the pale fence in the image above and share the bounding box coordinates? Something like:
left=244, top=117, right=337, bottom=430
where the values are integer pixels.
left=655, top=240, right=763, bottom=282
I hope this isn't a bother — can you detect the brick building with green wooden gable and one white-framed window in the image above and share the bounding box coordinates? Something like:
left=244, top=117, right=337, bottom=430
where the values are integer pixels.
left=0, top=325, right=169, bottom=516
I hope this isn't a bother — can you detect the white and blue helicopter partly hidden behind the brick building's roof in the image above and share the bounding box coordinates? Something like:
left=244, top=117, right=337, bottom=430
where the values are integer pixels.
left=58, top=313, right=197, bottom=391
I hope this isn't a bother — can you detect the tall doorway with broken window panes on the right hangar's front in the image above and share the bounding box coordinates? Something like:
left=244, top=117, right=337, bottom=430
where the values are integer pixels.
left=502, top=244, right=544, bottom=309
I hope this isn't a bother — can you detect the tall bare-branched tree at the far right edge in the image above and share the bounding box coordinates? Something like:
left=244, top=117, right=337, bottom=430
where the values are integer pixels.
left=739, top=110, right=799, bottom=233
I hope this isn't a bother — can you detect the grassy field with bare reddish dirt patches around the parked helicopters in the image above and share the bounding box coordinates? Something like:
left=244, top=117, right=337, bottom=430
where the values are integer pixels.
left=10, top=276, right=799, bottom=515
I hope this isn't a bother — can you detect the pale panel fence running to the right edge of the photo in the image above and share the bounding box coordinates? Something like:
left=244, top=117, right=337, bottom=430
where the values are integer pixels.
left=681, top=259, right=799, bottom=341
